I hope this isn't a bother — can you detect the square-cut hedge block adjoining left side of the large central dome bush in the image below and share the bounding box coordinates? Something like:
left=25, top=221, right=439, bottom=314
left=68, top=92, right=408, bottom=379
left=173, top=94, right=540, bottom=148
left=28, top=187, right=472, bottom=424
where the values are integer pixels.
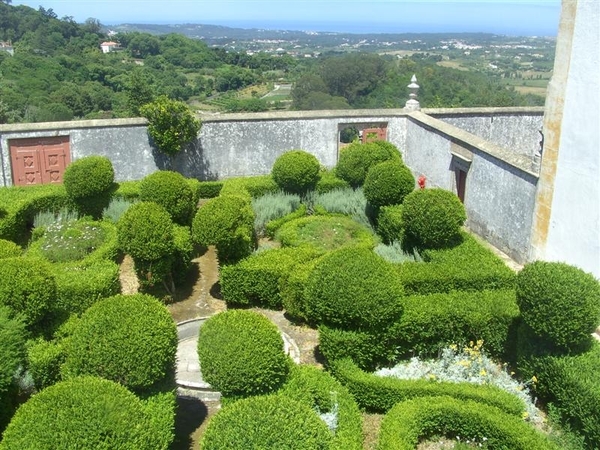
left=220, top=246, right=320, bottom=309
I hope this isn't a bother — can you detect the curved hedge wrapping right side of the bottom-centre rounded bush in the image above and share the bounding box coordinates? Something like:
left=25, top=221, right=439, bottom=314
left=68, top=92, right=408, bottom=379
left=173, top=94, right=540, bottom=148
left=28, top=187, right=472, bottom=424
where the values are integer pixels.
left=278, top=365, right=363, bottom=450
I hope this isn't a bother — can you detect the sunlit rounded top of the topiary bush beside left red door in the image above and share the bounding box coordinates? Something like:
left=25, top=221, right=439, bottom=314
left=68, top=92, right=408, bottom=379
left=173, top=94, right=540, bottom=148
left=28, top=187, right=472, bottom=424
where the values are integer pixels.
left=63, top=156, right=115, bottom=199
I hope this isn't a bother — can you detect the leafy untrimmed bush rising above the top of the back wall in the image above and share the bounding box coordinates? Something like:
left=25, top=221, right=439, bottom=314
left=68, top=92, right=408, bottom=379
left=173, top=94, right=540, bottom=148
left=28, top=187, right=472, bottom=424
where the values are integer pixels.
left=140, top=95, right=201, bottom=163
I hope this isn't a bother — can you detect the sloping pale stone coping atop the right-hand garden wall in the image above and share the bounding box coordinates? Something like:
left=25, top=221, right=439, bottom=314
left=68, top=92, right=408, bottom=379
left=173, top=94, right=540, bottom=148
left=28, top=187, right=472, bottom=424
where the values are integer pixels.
left=408, top=111, right=539, bottom=179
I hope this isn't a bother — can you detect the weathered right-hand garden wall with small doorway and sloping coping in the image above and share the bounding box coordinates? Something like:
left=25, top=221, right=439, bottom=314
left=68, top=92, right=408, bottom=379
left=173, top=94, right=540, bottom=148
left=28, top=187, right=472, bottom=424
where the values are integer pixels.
left=405, top=112, right=538, bottom=263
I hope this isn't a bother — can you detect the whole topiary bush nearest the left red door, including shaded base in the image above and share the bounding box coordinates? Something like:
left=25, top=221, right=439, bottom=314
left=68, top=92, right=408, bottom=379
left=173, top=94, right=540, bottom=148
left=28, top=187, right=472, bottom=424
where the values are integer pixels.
left=63, top=156, right=115, bottom=219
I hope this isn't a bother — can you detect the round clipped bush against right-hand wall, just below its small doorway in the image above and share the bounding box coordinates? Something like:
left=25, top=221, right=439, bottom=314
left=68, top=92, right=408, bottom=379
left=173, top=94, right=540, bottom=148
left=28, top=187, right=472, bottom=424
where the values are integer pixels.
left=402, top=188, right=467, bottom=248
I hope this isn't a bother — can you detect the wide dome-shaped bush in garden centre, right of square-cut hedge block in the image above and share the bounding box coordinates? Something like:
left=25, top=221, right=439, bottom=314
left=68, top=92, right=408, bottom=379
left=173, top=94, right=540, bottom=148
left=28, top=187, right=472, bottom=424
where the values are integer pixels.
left=306, top=247, right=404, bottom=331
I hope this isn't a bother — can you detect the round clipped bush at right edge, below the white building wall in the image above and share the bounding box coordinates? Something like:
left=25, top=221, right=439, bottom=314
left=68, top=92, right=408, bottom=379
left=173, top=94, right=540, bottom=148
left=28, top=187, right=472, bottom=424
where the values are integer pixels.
left=517, top=261, right=600, bottom=351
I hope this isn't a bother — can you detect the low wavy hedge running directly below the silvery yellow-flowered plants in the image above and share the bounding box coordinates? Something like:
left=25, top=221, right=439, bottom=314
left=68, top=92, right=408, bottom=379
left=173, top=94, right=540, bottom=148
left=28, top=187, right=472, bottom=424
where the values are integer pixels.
left=329, top=359, right=525, bottom=418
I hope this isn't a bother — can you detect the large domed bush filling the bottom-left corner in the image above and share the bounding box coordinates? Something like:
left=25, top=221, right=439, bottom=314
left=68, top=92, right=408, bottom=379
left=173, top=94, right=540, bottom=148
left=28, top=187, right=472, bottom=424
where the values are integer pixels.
left=0, top=377, right=168, bottom=450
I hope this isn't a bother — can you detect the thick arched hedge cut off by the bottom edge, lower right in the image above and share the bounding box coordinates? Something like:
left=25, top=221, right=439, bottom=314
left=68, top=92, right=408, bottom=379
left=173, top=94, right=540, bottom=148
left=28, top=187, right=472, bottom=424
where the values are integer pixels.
left=377, top=396, right=558, bottom=450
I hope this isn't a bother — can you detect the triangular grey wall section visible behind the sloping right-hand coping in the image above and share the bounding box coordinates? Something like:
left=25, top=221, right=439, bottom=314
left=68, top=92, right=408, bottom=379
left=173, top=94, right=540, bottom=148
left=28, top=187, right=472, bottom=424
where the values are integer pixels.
left=423, top=107, right=544, bottom=157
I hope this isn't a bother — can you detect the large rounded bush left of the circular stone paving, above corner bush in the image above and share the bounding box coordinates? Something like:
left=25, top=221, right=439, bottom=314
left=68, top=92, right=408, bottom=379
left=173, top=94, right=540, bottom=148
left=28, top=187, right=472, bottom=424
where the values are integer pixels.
left=63, top=294, right=177, bottom=392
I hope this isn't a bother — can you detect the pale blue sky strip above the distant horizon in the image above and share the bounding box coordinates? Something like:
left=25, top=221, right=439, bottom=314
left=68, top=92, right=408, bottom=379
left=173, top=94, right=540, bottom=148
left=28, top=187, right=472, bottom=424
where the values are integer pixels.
left=12, top=0, right=564, bottom=36
